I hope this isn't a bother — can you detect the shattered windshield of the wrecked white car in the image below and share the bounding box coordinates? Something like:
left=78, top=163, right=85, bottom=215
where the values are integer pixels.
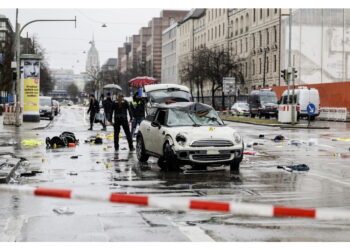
left=167, top=109, right=224, bottom=127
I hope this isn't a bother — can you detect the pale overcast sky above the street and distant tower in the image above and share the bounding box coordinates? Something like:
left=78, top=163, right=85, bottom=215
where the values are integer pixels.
left=0, top=8, right=167, bottom=73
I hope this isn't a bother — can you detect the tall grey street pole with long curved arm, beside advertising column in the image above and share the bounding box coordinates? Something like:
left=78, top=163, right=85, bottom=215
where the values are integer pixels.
left=15, top=9, right=77, bottom=127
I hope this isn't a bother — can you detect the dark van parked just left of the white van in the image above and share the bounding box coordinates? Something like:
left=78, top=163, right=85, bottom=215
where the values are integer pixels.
left=248, top=89, right=278, bottom=118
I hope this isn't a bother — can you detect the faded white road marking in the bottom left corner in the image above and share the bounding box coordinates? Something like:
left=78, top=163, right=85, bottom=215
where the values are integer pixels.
left=0, top=215, right=28, bottom=242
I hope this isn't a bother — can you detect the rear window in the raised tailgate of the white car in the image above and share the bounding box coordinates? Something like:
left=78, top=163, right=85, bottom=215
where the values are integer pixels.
left=148, top=89, right=191, bottom=103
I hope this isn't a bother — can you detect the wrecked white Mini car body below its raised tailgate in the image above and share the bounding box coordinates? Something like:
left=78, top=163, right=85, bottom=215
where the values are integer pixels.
left=136, top=102, right=243, bottom=170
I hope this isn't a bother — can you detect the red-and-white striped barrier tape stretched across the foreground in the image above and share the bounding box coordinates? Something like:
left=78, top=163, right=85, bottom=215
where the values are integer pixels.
left=0, top=185, right=350, bottom=220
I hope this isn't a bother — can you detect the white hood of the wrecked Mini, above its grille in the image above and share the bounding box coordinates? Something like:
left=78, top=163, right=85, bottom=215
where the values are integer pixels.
left=168, top=126, right=237, bottom=142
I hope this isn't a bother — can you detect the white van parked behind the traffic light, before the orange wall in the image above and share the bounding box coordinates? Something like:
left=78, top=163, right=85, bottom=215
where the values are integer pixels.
left=280, top=87, right=320, bottom=120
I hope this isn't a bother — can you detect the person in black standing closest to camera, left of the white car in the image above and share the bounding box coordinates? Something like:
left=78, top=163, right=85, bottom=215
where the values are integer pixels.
left=112, top=94, right=135, bottom=151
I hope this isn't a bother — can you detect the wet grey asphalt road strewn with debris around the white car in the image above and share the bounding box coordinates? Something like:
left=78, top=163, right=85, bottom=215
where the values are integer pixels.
left=0, top=106, right=350, bottom=242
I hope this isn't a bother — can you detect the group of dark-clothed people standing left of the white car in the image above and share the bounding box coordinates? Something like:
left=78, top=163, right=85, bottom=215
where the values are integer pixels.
left=87, top=93, right=145, bottom=151
